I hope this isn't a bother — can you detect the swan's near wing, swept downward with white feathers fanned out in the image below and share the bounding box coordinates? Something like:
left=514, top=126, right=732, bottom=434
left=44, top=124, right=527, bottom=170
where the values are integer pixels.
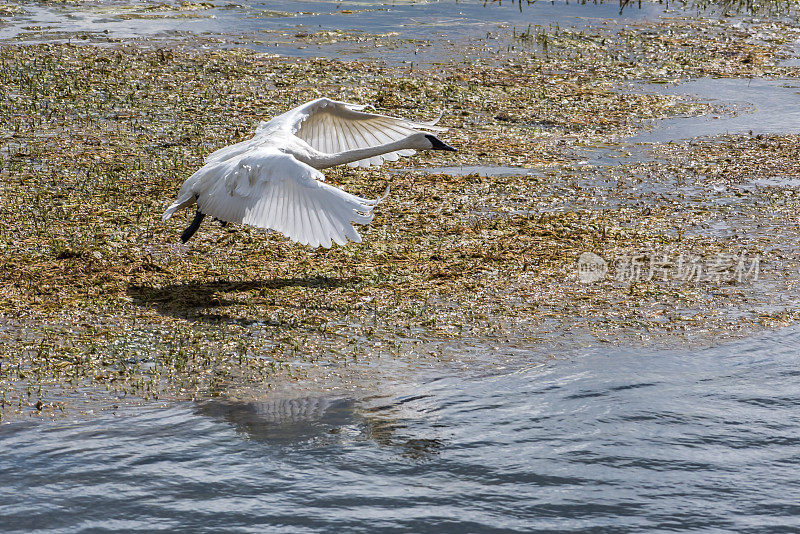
left=194, top=150, right=377, bottom=248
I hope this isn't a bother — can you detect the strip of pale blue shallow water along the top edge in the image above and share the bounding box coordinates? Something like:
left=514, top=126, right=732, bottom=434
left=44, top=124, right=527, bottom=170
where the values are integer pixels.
left=0, top=0, right=669, bottom=62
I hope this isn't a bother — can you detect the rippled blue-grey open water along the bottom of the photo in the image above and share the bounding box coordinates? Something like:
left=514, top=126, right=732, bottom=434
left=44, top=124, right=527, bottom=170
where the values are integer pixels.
left=0, top=328, right=800, bottom=532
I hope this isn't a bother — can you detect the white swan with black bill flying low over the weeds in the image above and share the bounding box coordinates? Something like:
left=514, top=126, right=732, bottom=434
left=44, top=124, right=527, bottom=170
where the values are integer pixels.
left=164, top=98, right=455, bottom=248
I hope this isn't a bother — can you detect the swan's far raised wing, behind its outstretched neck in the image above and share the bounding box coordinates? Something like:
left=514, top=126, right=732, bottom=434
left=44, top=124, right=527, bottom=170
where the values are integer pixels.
left=287, top=98, right=447, bottom=167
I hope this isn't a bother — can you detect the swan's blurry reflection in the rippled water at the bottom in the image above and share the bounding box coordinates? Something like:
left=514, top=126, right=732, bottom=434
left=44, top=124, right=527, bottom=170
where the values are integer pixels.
left=196, top=395, right=444, bottom=458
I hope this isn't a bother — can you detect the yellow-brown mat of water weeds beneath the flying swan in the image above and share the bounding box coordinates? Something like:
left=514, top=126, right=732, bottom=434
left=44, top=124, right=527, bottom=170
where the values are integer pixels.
left=0, top=3, right=800, bottom=418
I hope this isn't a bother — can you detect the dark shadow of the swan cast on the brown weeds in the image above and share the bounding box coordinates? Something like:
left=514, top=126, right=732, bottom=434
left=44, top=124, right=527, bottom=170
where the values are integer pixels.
left=127, top=276, right=360, bottom=326
